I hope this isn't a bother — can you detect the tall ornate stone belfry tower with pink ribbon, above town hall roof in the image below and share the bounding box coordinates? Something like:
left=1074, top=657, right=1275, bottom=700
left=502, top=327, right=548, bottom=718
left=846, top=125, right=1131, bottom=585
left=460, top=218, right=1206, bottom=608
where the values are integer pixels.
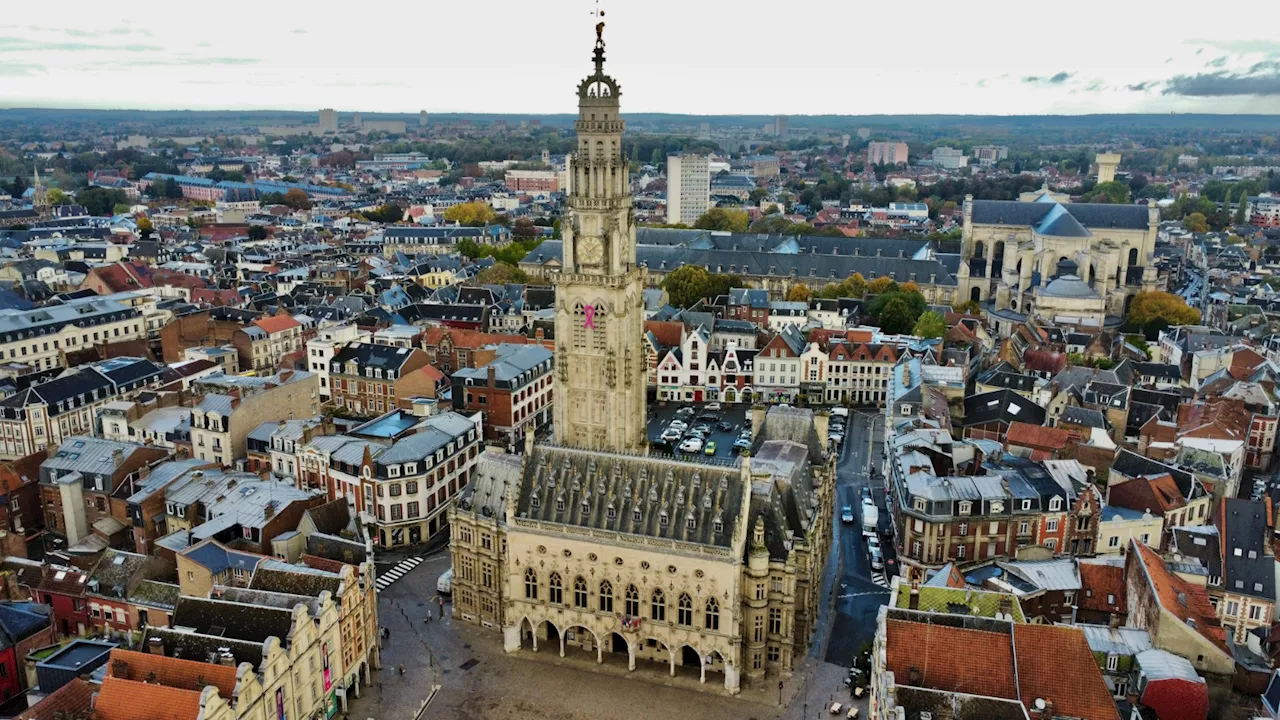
left=553, top=22, right=648, bottom=452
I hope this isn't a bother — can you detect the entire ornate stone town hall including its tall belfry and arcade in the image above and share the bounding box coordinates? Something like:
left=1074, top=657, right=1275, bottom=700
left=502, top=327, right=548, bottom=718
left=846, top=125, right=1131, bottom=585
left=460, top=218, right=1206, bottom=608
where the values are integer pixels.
left=449, top=26, right=835, bottom=693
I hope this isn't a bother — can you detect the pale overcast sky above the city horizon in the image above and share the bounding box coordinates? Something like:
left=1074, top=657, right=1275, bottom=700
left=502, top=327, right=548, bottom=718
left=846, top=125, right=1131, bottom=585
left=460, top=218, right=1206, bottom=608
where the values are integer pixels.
left=0, top=0, right=1280, bottom=115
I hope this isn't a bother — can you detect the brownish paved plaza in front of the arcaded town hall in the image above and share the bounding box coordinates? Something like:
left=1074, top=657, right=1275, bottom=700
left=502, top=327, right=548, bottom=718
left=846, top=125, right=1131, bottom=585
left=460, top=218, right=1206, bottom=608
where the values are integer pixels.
left=347, top=552, right=865, bottom=720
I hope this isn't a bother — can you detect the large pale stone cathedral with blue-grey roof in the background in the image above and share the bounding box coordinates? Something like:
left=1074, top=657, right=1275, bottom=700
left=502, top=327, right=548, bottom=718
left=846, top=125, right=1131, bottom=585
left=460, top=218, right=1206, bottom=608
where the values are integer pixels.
left=956, top=192, right=1160, bottom=334
